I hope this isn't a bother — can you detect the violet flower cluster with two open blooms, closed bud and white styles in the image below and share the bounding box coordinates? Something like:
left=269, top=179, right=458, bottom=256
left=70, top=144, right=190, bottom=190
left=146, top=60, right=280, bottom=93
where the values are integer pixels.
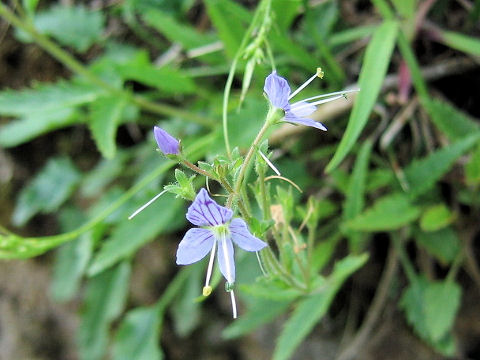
left=130, top=69, right=349, bottom=318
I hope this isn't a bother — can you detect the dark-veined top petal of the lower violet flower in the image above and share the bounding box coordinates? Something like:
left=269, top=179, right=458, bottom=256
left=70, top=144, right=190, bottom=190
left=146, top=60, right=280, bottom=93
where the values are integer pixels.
left=187, top=188, right=233, bottom=226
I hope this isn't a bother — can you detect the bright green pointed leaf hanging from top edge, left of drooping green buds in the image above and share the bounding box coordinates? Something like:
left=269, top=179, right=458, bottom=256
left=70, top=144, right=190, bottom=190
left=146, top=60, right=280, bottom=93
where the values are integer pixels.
left=205, top=0, right=250, bottom=58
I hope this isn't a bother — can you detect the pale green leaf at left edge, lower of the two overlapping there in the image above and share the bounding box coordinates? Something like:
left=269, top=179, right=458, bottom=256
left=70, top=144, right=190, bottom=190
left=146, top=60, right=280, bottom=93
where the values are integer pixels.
left=0, top=107, right=78, bottom=148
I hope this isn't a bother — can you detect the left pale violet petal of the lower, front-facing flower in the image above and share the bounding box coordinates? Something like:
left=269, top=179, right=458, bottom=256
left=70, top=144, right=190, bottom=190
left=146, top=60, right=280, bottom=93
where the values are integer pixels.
left=177, top=228, right=215, bottom=265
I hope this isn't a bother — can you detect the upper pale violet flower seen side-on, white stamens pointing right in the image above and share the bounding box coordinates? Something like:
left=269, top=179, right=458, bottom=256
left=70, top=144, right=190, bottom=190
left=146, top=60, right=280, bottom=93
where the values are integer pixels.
left=263, top=68, right=358, bottom=131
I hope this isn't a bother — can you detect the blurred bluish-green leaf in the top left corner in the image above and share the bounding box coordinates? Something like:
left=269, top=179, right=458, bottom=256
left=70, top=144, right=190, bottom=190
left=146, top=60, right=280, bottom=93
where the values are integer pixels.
left=29, top=5, right=105, bottom=52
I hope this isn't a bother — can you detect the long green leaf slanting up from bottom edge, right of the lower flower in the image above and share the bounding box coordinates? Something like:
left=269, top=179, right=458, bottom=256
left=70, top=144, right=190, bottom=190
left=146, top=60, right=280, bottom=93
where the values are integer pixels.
left=273, top=254, right=368, bottom=360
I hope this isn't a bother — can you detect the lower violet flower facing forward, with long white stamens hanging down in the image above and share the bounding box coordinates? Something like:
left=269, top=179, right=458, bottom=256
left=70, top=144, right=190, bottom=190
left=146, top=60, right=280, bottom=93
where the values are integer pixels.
left=177, top=189, right=267, bottom=318
